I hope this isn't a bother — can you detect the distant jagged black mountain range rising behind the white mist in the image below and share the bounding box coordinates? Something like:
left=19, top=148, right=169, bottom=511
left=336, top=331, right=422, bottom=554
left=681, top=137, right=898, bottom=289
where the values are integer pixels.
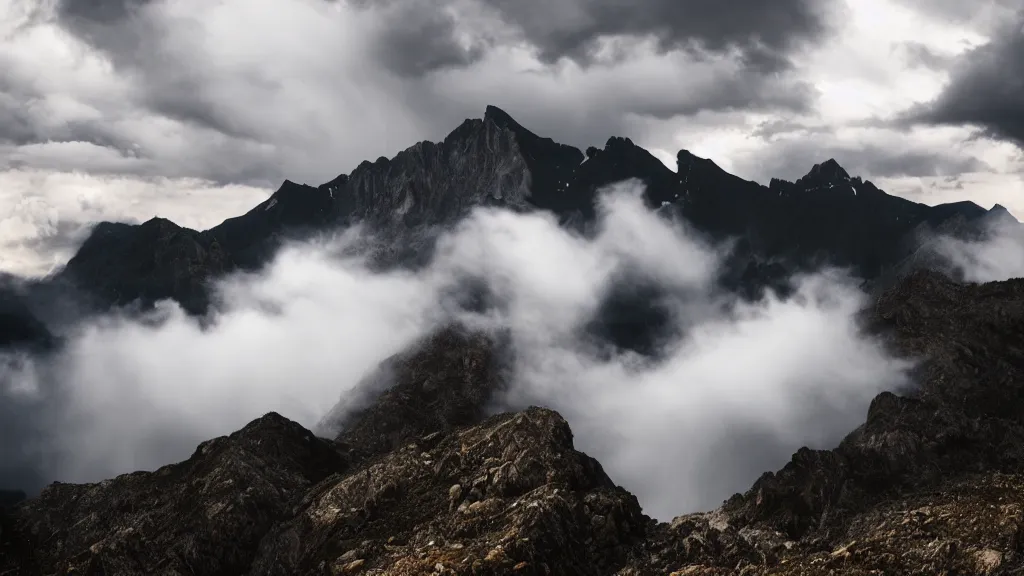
left=0, top=107, right=1016, bottom=352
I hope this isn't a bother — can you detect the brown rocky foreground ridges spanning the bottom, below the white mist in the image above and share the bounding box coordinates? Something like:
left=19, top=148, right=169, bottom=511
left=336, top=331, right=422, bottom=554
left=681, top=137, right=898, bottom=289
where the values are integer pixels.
left=0, top=272, right=1024, bottom=576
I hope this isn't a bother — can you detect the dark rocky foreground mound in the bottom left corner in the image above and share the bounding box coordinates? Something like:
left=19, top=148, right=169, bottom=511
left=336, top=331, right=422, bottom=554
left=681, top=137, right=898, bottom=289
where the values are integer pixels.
left=0, top=414, right=345, bottom=574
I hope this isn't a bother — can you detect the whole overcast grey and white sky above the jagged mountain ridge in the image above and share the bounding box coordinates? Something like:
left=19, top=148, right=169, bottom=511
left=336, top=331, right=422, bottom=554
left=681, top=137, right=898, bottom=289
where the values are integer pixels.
left=0, top=0, right=1024, bottom=275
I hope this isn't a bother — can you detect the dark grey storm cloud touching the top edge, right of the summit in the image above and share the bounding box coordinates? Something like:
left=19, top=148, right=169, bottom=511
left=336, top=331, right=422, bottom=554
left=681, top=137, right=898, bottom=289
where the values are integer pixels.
left=471, top=0, right=834, bottom=71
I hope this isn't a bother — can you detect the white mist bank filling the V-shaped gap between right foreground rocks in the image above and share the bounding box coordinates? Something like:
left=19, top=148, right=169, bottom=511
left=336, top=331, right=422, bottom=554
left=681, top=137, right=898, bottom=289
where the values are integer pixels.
left=510, top=268, right=905, bottom=520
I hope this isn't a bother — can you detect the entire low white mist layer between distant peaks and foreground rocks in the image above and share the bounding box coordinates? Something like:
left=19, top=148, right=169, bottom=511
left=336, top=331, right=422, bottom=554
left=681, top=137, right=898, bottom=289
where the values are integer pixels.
left=0, top=184, right=906, bottom=519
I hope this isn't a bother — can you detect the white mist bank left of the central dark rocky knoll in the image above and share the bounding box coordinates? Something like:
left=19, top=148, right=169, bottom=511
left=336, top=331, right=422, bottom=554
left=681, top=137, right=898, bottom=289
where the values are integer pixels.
left=22, top=228, right=437, bottom=481
